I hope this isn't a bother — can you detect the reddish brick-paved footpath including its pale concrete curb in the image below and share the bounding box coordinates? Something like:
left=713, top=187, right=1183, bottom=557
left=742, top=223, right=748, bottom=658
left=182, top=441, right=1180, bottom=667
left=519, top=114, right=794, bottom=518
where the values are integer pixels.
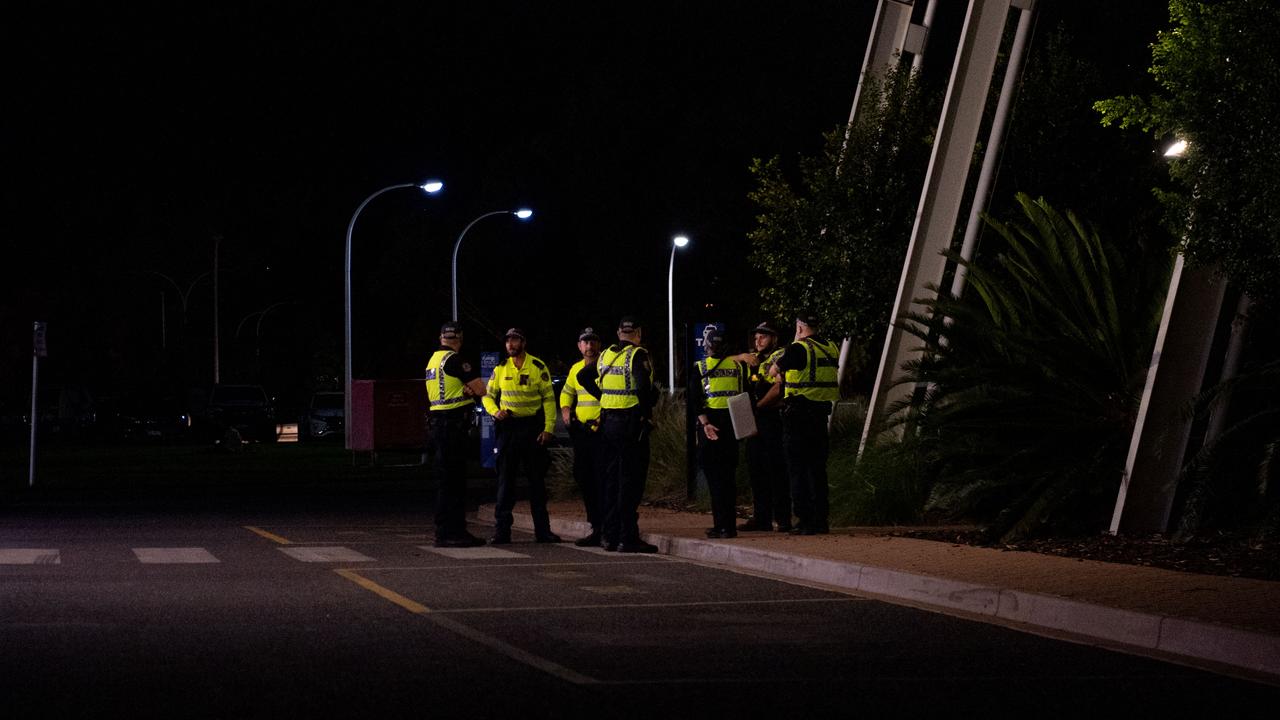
left=476, top=501, right=1280, bottom=684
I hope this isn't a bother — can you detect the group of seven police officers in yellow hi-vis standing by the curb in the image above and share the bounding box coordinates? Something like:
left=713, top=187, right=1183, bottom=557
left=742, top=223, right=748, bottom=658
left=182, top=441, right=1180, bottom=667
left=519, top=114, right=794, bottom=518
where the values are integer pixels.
left=426, top=314, right=838, bottom=552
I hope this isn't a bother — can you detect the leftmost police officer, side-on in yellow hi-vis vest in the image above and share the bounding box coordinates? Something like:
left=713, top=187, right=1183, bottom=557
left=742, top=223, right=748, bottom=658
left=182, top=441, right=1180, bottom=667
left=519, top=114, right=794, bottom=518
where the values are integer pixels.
left=426, top=323, right=485, bottom=547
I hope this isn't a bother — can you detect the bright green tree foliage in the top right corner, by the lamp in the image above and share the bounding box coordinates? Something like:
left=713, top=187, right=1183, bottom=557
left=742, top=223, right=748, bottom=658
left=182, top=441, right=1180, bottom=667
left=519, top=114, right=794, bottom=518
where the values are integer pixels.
left=1094, top=0, right=1280, bottom=305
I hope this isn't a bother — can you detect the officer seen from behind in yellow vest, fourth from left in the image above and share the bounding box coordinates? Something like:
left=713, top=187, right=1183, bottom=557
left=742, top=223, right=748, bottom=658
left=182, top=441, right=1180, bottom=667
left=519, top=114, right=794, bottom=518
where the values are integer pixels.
left=591, top=315, right=658, bottom=552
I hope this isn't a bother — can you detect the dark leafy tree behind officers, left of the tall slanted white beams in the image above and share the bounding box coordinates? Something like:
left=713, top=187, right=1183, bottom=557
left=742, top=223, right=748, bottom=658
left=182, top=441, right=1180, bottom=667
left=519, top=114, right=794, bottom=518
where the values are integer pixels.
left=748, top=68, right=937, bottom=342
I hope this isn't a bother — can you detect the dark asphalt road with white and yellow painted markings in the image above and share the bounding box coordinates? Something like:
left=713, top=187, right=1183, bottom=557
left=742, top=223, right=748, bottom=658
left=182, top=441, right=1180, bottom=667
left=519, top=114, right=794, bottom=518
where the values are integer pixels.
left=0, top=486, right=1280, bottom=719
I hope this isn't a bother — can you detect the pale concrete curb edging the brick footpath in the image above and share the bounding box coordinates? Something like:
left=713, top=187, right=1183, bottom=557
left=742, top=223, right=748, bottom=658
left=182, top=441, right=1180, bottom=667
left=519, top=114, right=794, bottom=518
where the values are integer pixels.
left=480, top=505, right=1280, bottom=679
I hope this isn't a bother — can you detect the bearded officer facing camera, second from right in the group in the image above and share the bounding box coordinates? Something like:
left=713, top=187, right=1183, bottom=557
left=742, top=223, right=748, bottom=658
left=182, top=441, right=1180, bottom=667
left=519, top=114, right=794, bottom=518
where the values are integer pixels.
left=737, top=323, right=791, bottom=533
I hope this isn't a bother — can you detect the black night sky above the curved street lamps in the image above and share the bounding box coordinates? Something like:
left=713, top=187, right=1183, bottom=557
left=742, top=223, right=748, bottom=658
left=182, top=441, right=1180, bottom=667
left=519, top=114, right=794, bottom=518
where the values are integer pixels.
left=0, top=0, right=874, bottom=397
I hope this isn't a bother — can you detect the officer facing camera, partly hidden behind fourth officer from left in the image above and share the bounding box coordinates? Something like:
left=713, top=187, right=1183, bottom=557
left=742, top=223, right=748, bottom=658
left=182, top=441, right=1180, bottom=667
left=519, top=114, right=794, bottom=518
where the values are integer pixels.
left=561, top=328, right=604, bottom=547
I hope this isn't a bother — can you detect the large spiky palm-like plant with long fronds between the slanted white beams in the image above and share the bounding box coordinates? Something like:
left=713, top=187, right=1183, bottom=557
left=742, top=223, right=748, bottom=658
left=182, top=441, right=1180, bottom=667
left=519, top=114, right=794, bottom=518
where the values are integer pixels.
left=891, top=193, right=1169, bottom=539
